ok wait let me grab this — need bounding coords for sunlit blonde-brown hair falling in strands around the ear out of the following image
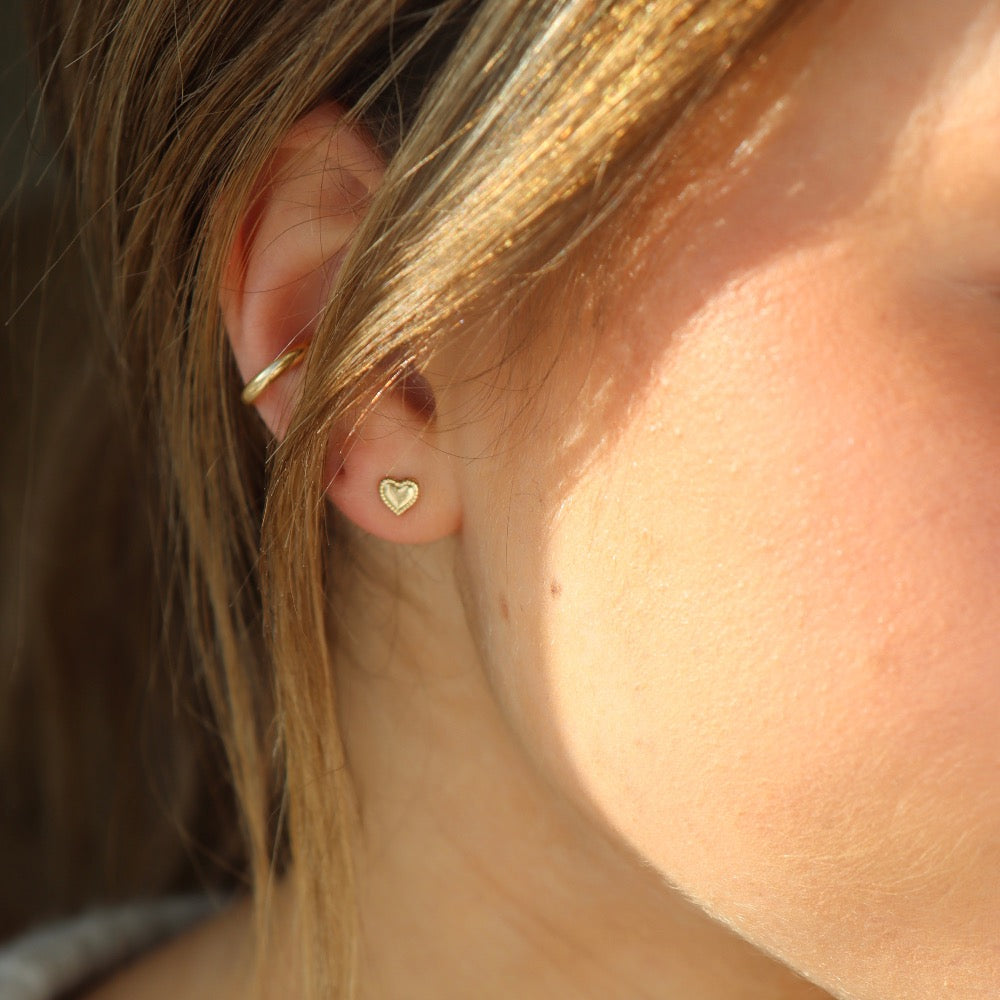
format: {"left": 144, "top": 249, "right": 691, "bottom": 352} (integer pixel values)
{"left": 25, "top": 0, "right": 804, "bottom": 996}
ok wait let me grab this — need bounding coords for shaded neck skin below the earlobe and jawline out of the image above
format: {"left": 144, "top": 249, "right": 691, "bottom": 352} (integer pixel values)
{"left": 324, "top": 547, "right": 827, "bottom": 1000}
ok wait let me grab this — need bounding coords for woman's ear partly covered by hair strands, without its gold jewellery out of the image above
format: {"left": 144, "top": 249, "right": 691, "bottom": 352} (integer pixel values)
{"left": 220, "top": 103, "right": 461, "bottom": 544}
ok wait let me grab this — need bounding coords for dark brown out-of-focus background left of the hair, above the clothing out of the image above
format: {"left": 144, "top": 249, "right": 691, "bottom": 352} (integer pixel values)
{"left": 0, "top": 0, "right": 242, "bottom": 942}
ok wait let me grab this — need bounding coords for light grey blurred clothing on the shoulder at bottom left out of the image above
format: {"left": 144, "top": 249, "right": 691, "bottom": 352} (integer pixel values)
{"left": 0, "top": 897, "right": 215, "bottom": 1000}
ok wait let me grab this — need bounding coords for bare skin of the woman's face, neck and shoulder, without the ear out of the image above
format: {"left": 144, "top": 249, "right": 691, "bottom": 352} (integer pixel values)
{"left": 90, "top": 0, "right": 1000, "bottom": 1000}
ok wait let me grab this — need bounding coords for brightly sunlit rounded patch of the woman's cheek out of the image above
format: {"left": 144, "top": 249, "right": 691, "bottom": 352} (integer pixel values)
{"left": 539, "top": 256, "right": 1000, "bottom": 984}
